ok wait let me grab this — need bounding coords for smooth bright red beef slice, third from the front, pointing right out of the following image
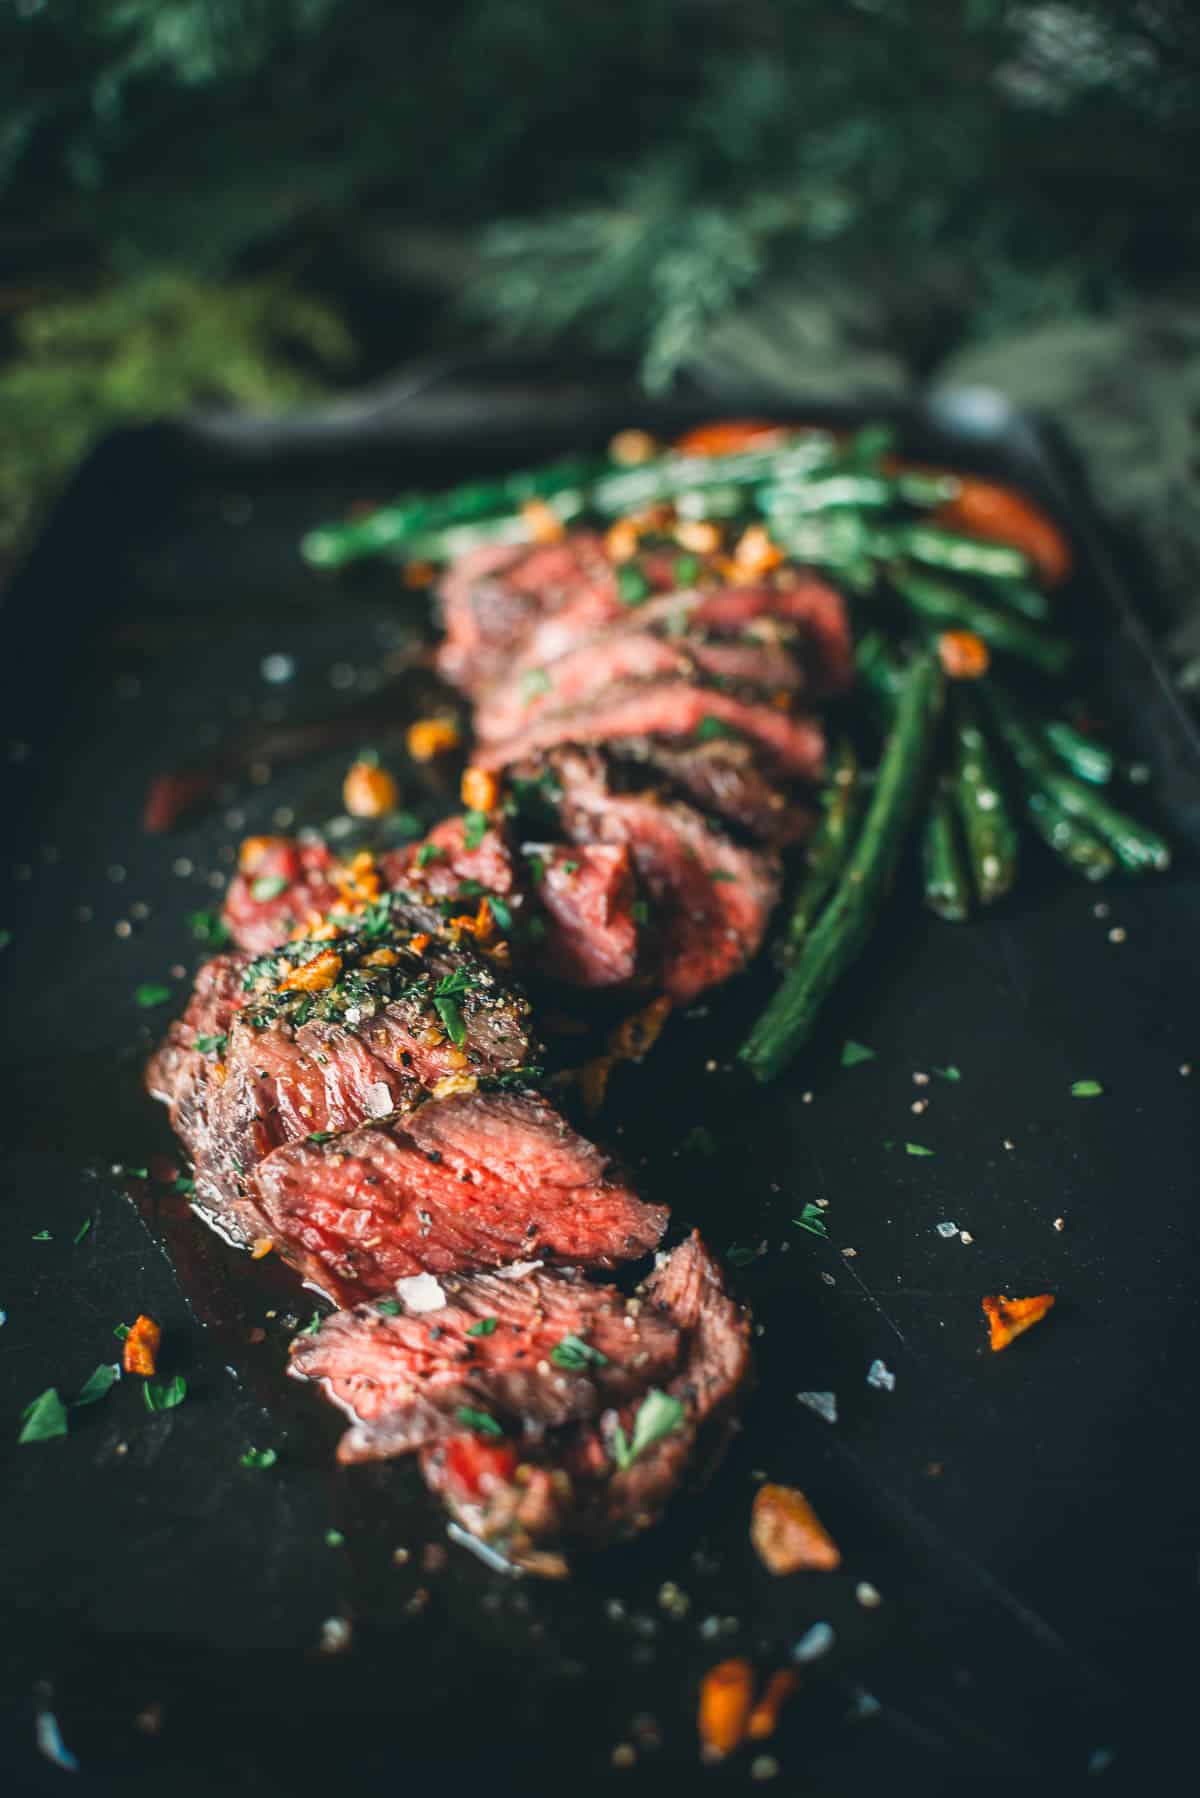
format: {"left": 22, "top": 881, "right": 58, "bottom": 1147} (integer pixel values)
{"left": 252, "top": 1091, "right": 666, "bottom": 1304}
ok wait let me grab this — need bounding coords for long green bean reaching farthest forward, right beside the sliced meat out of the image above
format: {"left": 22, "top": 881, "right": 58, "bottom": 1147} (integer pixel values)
{"left": 738, "top": 651, "right": 945, "bottom": 1081}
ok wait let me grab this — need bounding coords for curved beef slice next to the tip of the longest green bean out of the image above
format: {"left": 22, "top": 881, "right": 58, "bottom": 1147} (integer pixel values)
{"left": 547, "top": 750, "right": 781, "bottom": 1005}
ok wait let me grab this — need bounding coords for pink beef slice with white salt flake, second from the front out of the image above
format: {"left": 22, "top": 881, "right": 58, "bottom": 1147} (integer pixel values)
{"left": 290, "top": 1269, "right": 680, "bottom": 1462}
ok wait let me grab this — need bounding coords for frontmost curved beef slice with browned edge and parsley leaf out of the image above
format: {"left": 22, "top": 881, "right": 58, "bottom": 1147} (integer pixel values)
{"left": 421, "top": 1235, "right": 750, "bottom": 1562}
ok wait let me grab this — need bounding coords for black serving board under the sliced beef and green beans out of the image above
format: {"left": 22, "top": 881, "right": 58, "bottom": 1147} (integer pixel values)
{"left": 0, "top": 367, "right": 1200, "bottom": 1798}
